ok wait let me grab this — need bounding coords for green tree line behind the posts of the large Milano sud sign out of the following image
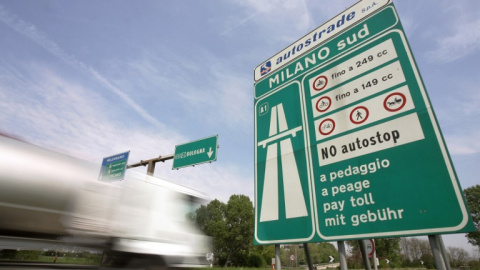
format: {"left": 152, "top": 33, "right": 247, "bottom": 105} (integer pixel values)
{"left": 187, "top": 185, "right": 480, "bottom": 269}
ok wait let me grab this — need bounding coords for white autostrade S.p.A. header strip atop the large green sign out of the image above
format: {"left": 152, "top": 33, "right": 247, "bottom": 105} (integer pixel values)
{"left": 254, "top": 0, "right": 391, "bottom": 82}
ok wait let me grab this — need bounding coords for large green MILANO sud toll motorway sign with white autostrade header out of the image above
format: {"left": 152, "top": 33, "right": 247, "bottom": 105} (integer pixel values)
{"left": 255, "top": 0, "right": 473, "bottom": 244}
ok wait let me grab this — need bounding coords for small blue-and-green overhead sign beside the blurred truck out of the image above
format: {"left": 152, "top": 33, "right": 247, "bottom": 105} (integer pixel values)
{"left": 99, "top": 151, "right": 130, "bottom": 181}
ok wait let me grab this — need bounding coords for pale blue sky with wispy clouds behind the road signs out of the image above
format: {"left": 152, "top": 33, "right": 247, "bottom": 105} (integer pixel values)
{"left": 0, "top": 0, "right": 480, "bottom": 254}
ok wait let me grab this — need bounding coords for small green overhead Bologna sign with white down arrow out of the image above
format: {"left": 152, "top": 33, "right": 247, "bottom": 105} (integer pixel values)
{"left": 172, "top": 135, "right": 218, "bottom": 169}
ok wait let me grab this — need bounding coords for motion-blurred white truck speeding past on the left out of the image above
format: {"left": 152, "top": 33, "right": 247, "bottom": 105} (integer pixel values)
{"left": 0, "top": 136, "right": 210, "bottom": 269}
